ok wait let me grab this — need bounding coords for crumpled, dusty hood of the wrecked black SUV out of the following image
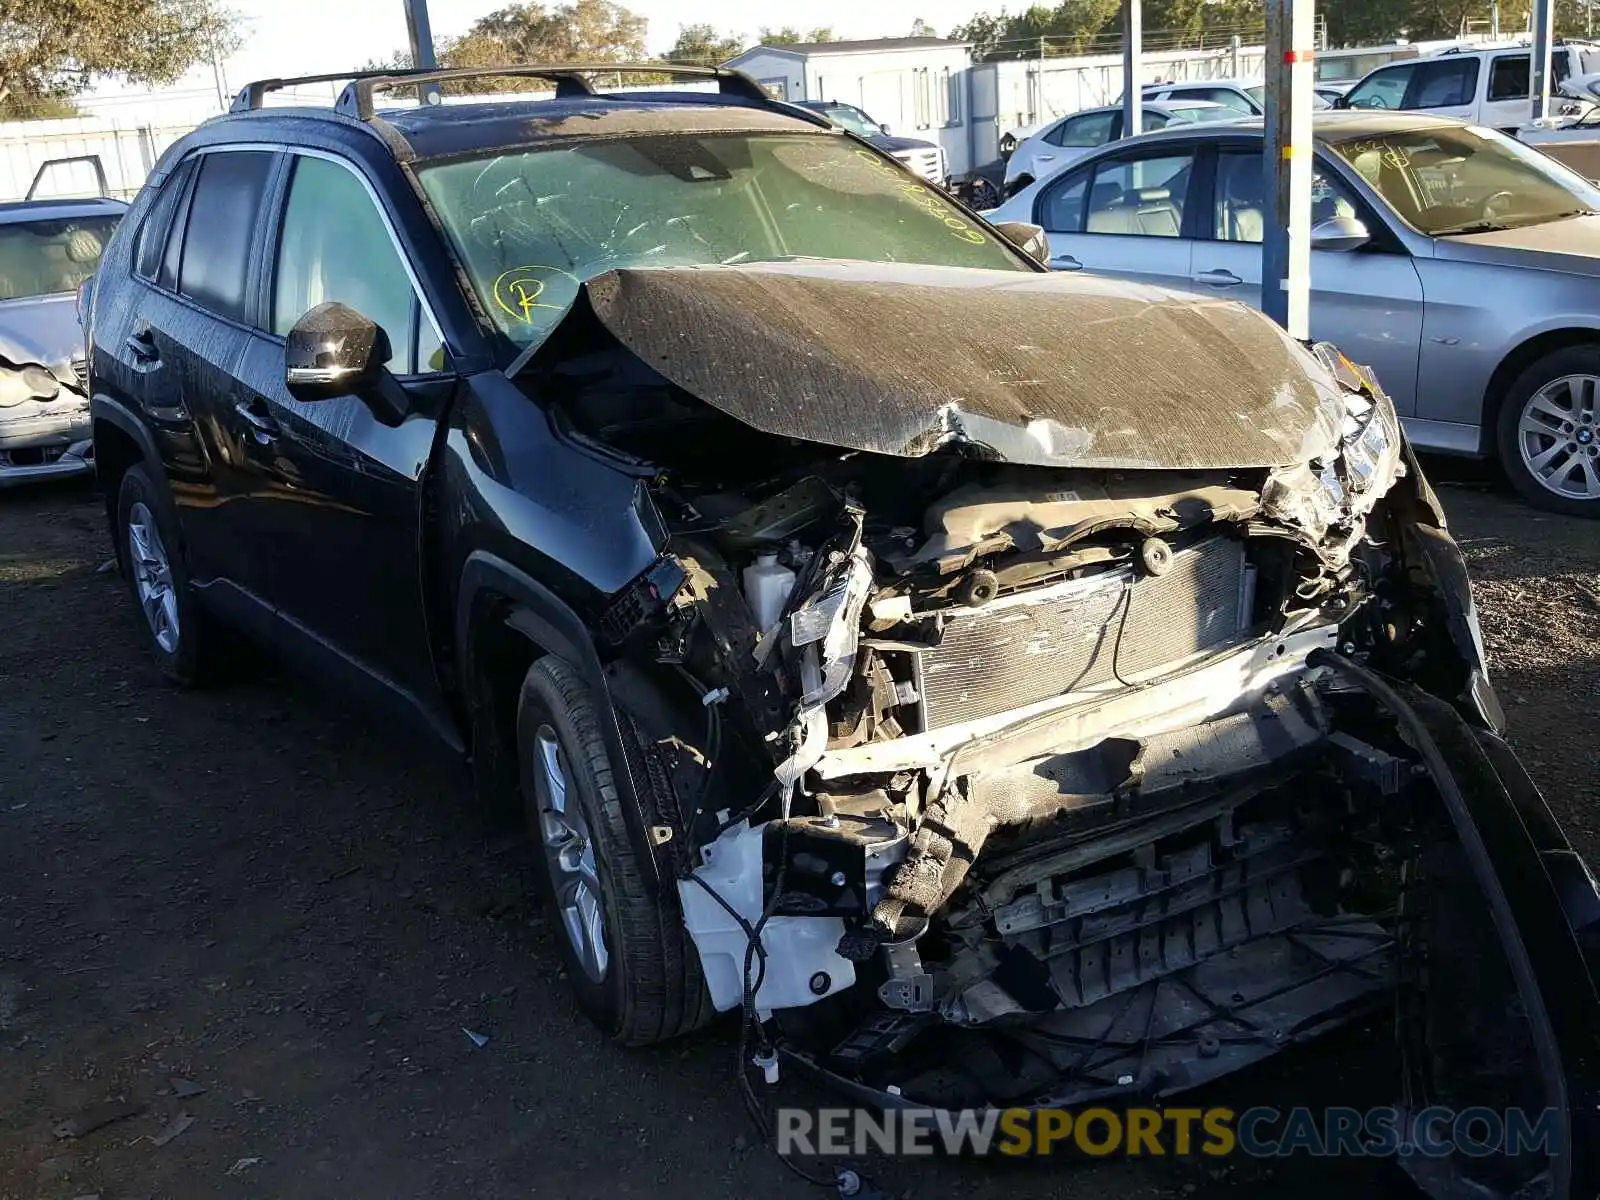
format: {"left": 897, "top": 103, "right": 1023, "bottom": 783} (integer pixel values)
{"left": 586, "top": 261, "right": 1342, "bottom": 470}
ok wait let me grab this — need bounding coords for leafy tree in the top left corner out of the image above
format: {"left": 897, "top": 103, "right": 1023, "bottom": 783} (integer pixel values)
{"left": 0, "top": 0, "right": 238, "bottom": 117}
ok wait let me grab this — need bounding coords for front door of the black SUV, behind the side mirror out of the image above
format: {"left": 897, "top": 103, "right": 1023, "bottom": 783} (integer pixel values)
{"left": 225, "top": 155, "right": 451, "bottom": 732}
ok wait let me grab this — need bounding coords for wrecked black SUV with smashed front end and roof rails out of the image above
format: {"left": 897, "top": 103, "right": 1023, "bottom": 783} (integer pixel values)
{"left": 90, "top": 62, "right": 1600, "bottom": 1200}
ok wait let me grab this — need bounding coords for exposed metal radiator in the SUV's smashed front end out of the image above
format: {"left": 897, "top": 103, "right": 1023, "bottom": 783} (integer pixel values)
{"left": 917, "top": 536, "right": 1248, "bottom": 730}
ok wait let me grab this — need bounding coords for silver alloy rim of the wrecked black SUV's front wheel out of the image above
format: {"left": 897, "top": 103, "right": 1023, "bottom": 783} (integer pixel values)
{"left": 534, "top": 725, "right": 611, "bottom": 984}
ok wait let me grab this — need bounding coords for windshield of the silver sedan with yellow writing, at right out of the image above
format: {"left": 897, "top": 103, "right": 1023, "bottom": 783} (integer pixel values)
{"left": 1330, "top": 125, "right": 1600, "bottom": 237}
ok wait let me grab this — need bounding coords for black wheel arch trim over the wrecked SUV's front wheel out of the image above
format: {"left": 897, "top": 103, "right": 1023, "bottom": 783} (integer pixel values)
{"left": 456, "top": 549, "right": 672, "bottom": 893}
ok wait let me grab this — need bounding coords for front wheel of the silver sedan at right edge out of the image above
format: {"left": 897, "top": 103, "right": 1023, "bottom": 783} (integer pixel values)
{"left": 1498, "top": 346, "right": 1600, "bottom": 517}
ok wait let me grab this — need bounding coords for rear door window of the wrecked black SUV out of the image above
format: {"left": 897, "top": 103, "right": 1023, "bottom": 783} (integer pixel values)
{"left": 178, "top": 150, "right": 272, "bottom": 320}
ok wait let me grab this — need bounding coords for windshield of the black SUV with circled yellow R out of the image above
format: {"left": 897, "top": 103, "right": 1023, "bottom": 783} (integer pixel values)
{"left": 418, "top": 134, "right": 1027, "bottom": 346}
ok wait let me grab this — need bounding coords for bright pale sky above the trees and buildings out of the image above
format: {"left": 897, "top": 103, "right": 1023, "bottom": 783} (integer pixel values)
{"left": 216, "top": 0, "right": 985, "bottom": 88}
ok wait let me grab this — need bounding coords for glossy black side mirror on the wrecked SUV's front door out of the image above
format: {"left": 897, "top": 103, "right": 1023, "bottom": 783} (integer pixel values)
{"left": 283, "top": 301, "right": 406, "bottom": 424}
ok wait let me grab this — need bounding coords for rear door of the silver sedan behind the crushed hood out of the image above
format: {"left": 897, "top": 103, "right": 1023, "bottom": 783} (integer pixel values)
{"left": 1034, "top": 141, "right": 1195, "bottom": 288}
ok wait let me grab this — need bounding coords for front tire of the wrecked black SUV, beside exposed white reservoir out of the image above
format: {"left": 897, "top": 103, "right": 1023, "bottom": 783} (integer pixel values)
{"left": 517, "top": 658, "right": 715, "bottom": 1046}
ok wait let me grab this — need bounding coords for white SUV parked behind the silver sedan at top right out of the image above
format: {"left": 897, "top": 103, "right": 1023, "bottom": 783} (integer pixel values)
{"left": 1334, "top": 42, "right": 1600, "bottom": 133}
